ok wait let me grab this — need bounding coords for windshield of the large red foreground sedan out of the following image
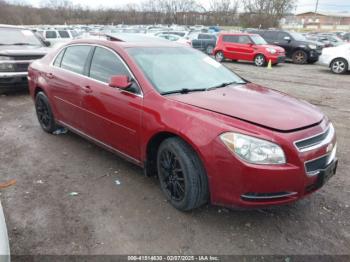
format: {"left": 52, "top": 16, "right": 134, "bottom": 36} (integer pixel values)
{"left": 128, "top": 47, "right": 245, "bottom": 93}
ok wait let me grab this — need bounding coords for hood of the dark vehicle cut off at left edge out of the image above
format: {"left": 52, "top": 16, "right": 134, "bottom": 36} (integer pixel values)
{"left": 0, "top": 45, "right": 50, "bottom": 56}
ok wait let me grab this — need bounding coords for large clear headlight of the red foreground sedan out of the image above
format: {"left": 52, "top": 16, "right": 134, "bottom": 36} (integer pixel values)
{"left": 220, "top": 132, "right": 286, "bottom": 165}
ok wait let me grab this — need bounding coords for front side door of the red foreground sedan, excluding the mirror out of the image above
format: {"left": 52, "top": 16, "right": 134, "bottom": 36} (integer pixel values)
{"left": 83, "top": 46, "right": 143, "bottom": 159}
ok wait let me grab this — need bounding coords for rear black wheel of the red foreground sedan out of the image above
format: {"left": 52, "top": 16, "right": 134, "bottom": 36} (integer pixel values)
{"left": 35, "top": 92, "right": 57, "bottom": 133}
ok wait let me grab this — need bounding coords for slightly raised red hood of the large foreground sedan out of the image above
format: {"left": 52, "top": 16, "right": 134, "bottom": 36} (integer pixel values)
{"left": 168, "top": 83, "right": 324, "bottom": 132}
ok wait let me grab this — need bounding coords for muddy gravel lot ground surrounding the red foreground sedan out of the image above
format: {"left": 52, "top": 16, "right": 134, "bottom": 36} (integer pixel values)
{"left": 0, "top": 63, "right": 350, "bottom": 255}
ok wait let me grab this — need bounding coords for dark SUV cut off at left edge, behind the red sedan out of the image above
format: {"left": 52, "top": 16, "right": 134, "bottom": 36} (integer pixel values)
{"left": 0, "top": 25, "right": 48, "bottom": 94}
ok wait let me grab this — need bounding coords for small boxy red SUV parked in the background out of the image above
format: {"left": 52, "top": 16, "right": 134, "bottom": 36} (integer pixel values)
{"left": 214, "top": 33, "right": 286, "bottom": 66}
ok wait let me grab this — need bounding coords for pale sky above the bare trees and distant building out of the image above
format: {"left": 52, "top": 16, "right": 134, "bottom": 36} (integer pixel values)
{"left": 14, "top": 0, "right": 350, "bottom": 13}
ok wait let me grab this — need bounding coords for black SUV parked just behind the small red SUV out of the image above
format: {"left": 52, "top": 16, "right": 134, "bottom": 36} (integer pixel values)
{"left": 249, "top": 30, "right": 324, "bottom": 64}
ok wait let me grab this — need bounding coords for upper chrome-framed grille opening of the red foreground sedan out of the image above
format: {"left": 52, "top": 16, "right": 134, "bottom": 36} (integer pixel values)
{"left": 294, "top": 124, "right": 335, "bottom": 152}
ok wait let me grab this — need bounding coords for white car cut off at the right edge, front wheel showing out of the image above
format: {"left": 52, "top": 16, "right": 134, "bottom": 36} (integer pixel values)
{"left": 319, "top": 43, "right": 350, "bottom": 74}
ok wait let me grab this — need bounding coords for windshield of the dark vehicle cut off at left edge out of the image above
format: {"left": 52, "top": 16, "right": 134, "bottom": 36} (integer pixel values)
{"left": 0, "top": 28, "right": 42, "bottom": 46}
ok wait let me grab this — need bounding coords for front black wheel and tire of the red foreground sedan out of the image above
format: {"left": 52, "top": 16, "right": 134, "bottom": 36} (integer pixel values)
{"left": 157, "top": 138, "right": 209, "bottom": 211}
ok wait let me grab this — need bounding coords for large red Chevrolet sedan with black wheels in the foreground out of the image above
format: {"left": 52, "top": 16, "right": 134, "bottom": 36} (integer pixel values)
{"left": 28, "top": 40, "right": 337, "bottom": 211}
